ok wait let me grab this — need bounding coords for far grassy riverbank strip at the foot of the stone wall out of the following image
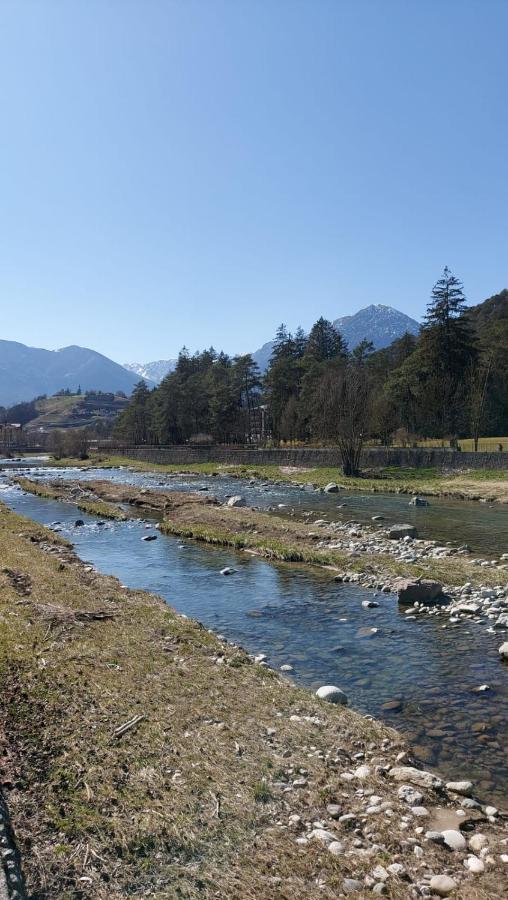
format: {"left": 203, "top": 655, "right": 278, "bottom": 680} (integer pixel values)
{"left": 49, "top": 454, "right": 508, "bottom": 503}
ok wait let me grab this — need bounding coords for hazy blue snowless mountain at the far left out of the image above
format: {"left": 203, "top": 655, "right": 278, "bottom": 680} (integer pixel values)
{"left": 0, "top": 340, "right": 143, "bottom": 406}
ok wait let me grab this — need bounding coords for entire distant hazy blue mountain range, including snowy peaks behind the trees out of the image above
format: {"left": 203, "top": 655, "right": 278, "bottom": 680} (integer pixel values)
{"left": 0, "top": 304, "right": 420, "bottom": 406}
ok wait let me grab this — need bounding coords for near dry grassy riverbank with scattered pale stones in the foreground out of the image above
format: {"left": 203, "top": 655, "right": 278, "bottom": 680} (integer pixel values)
{"left": 0, "top": 505, "right": 506, "bottom": 900}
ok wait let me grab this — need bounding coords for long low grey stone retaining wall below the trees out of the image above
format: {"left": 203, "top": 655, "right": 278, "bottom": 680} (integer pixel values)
{"left": 104, "top": 446, "right": 508, "bottom": 470}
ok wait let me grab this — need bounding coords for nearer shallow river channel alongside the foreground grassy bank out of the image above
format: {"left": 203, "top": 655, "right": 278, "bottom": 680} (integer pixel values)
{"left": 0, "top": 470, "right": 508, "bottom": 804}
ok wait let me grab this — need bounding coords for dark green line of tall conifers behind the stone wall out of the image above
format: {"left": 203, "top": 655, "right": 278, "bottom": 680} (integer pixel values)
{"left": 115, "top": 268, "right": 508, "bottom": 472}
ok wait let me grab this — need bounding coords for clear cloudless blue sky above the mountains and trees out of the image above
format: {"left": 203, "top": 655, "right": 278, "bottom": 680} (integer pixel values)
{"left": 0, "top": 0, "right": 508, "bottom": 362}
